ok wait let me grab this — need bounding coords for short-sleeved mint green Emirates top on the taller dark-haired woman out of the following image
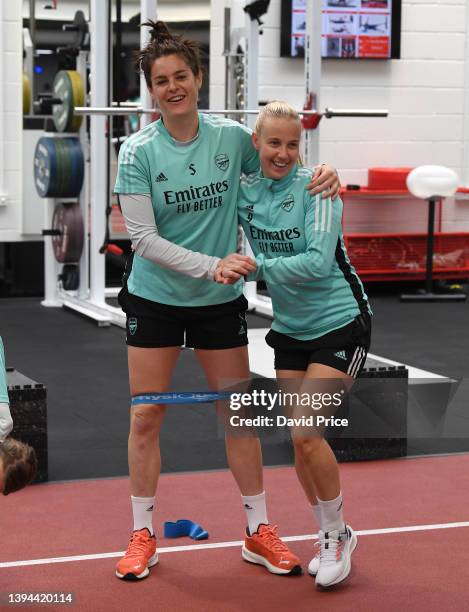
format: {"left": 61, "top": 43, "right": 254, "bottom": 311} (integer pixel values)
{"left": 115, "top": 113, "right": 259, "bottom": 306}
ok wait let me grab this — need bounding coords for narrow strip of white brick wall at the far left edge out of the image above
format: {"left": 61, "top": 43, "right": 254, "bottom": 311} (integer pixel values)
{"left": 0, "top": 2, "right": 23, "bottom": 240}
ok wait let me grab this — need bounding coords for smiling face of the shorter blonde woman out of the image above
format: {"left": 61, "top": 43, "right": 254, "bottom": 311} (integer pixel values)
{"left": 252, "top": 117, "right": 301, "bottom": 180}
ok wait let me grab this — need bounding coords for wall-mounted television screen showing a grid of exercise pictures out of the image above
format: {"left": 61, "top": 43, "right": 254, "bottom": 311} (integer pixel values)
{"left": 280, "top": 0, "right": 401, "bottom": 59}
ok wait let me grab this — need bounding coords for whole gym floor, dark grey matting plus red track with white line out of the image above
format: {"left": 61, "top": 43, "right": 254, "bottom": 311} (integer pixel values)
{"left": 0, "top": 285, "right": 469, "bottom": 611}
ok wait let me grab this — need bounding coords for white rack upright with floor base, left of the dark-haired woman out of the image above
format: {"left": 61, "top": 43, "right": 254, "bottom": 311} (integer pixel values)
{"left": 42, "top": 0, "right": 158, "bottom": 327}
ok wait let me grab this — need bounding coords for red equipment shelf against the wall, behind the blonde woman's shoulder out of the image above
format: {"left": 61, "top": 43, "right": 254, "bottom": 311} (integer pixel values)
{"left": 341, "top": 187, "right": 469, "bottom": 281}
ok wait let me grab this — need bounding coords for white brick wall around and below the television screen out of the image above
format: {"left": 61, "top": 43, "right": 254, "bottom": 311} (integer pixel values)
{"left": 210, "top": 0, "right": 469, "bottom": 186}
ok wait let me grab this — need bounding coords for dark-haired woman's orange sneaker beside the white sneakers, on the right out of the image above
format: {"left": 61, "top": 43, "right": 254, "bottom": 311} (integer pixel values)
{"left": 242, "top": 524, "right": 301, "bottom": 575}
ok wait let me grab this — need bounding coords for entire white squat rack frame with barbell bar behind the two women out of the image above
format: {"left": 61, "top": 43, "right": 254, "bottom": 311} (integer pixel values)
{"left": 42, "top": 0, "right": 388, "bottom": 327}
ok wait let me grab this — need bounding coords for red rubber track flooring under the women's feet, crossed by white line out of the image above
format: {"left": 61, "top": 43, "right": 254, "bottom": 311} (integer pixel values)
{"left": 0, "top": 455, "right": 469, "bottom": 612}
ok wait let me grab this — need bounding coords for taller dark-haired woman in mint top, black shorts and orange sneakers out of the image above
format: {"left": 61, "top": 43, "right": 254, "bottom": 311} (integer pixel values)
{"left": 115, "top": 21, "right": 339, "bottom": 580}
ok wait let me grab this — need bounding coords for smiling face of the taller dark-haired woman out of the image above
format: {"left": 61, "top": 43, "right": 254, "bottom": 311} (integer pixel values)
{"left": 149, "top": 54, "right": 202, "bottom": 121}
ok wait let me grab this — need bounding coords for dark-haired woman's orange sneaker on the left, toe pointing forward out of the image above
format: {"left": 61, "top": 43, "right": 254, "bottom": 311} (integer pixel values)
{"left": 116, "top": 527, "right": 158, "bottom": 580}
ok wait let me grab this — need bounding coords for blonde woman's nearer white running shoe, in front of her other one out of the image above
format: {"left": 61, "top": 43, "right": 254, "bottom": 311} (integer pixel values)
{"left": 316, "top": 525, "right": 357, "bottom": 587}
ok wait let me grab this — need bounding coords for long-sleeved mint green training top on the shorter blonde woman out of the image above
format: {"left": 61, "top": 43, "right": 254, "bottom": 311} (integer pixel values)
{"left": 238, "top": 166, "right": 371, "bottom": 340}
